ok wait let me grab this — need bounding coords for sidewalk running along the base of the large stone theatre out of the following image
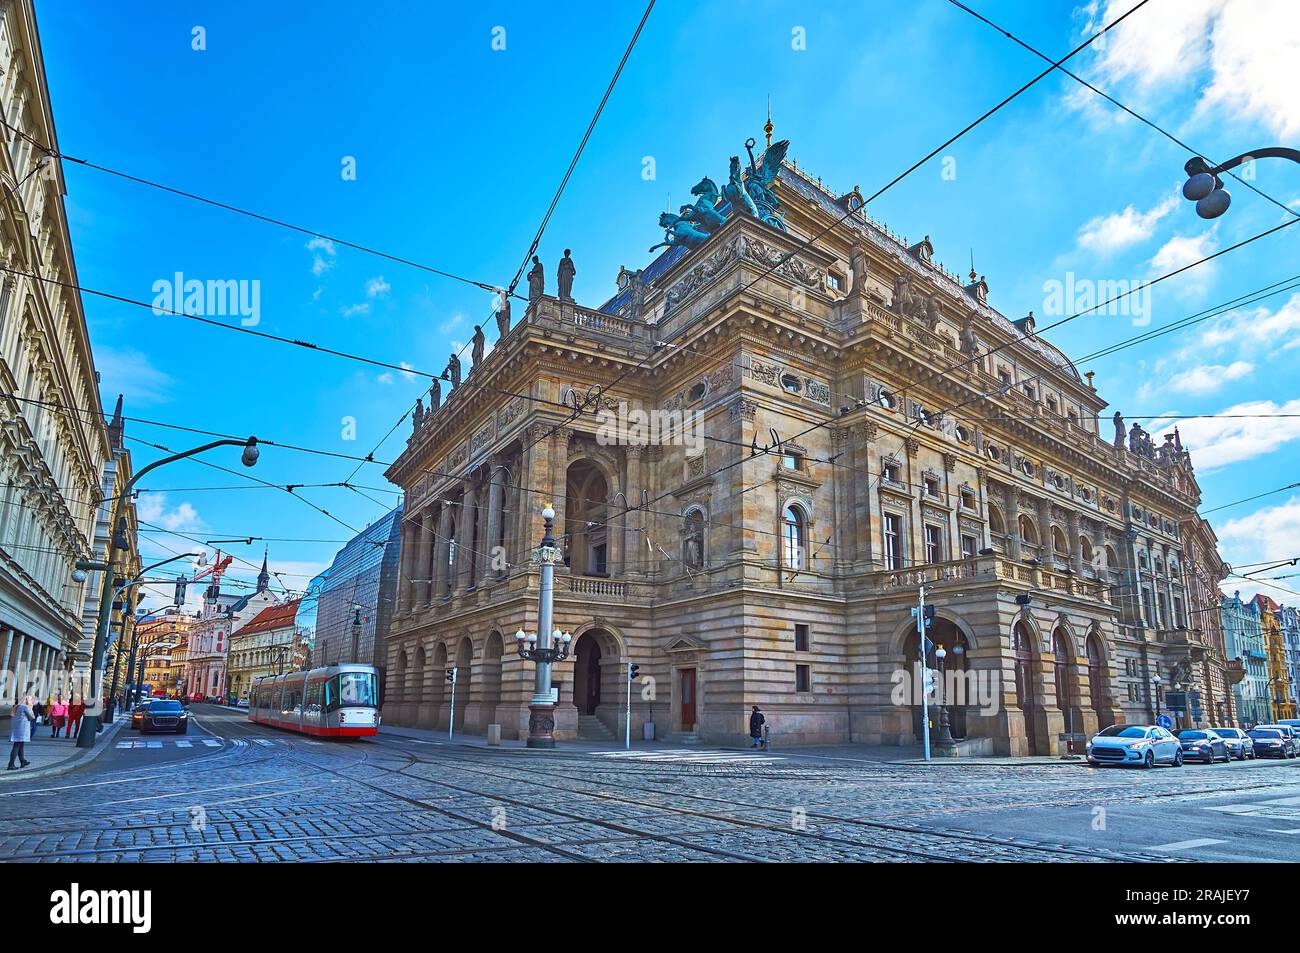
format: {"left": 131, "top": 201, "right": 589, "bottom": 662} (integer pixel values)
{"left": 380, "top": 725, "right": 1088, "bottom": 767}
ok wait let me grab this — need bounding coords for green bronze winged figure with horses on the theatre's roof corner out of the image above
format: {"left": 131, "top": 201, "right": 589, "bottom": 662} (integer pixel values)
{"left": 650, "top": 139, "right": 790, "bottom": 251}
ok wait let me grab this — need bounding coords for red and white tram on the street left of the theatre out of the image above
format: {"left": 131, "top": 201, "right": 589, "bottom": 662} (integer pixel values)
{"left": 248, "top": 663, "right": 380, "bottom": 738}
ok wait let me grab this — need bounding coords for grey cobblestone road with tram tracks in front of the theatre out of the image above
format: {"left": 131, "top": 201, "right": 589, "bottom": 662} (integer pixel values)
{"left": 0, "top": 706, "right": 1300, "bottom": 863}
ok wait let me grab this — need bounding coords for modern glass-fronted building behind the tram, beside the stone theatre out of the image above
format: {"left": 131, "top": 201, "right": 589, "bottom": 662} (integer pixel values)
{"left": 308, "top": 506, "right": 402, "bottom": 685}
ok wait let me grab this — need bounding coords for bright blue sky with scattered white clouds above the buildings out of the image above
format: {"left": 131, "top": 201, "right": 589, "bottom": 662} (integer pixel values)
{"left": 30, "top": 0, "right": 1300, "bottom": 601}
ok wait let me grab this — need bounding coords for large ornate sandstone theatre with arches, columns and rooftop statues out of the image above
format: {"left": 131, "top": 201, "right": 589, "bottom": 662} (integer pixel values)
{"left": 384, "top": 140, "right": 1232, "bottom": 755}
